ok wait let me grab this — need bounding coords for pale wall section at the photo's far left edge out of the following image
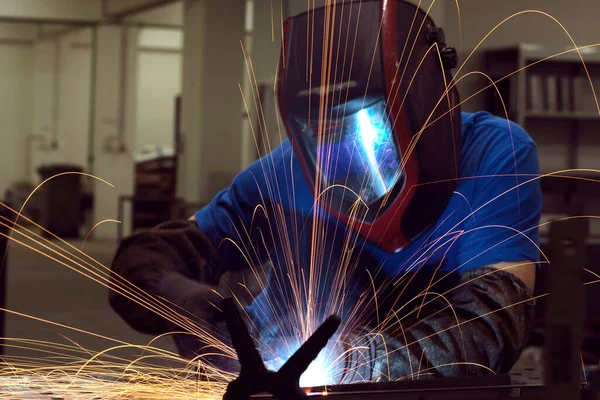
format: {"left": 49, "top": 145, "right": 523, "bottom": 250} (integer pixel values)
{"left": 0, "top": 43, "right": 33, "bottom": 196}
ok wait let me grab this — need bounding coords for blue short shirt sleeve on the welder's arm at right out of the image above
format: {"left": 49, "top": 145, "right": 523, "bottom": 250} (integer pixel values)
{"left": 457, "top": 123, "right": 542, "bottom": 271}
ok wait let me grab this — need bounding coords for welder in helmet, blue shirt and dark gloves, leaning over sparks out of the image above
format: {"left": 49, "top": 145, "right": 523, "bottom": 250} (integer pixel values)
{"left": 110, "top": 0, "right": 541, "bottom": 383}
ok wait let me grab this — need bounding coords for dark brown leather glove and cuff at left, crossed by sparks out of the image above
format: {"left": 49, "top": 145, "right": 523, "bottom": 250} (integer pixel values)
{"left": 109, "top": 221, "right": 226, "bottom": 356}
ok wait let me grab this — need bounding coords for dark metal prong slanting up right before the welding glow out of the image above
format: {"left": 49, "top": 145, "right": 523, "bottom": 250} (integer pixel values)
{"left": 279, "top": 315, "right": 342, "bottom": 380}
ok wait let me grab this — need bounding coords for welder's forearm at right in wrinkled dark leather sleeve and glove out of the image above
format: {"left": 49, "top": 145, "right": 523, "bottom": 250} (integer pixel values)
{"left": 344, "top": 262, "right": 535, "bottom": 383}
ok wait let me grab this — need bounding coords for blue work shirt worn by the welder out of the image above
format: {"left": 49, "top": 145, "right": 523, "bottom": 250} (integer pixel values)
{"left": 196, "top": 112, "right": 542, "bottom": 348}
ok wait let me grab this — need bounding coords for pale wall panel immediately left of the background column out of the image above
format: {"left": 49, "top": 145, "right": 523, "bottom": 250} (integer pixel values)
{"left": 30, "top": 29, "right": 92, "bottom": 183}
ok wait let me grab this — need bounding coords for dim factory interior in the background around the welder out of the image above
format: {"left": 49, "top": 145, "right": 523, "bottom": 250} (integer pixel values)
{"left": 0, "top": 0, "right": 600, "bottom": 399}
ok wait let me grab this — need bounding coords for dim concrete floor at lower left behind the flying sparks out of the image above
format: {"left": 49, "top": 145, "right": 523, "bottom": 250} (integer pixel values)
{"left": 5, "top": 241, "right": 175, "bottom": 366}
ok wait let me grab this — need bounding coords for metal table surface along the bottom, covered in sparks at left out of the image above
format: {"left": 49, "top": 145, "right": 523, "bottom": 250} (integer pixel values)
{"left": 0, "top": 370, "right": 543, "bottom": 400}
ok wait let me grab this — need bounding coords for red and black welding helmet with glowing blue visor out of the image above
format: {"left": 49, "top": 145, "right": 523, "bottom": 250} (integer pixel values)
{"left": 278, "top": 0, "right": 461, "bottom": 252}
